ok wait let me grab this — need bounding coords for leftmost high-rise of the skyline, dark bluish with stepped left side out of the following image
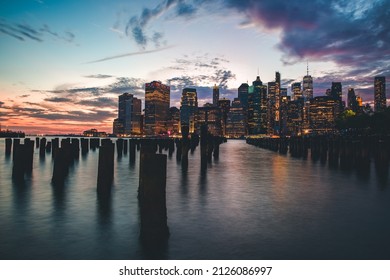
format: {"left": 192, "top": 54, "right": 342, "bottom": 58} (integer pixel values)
{"left": 113, "top": 92, "right": 141, "bottom": 135}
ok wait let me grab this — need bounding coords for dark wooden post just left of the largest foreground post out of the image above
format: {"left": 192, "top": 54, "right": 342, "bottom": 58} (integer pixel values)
{"left": 97, "top": 139, "right": 115, "bottom": 194}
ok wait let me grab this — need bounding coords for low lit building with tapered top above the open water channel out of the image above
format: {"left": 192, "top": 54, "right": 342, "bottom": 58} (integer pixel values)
{"left": 225, "top": 98, "right": 246, "bottom": 138}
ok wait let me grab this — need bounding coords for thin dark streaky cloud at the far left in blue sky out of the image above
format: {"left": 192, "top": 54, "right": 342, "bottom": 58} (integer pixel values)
{"left": 0, "top": 19, "right": 75, "bottom": 43}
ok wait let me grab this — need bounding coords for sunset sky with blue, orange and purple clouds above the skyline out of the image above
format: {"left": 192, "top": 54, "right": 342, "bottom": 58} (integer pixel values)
{"left": 0, "top": 0, "right": 390, "bottom": 134}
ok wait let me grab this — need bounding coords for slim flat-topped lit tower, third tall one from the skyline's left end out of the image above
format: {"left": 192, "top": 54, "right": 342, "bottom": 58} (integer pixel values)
{"left": 180, "top": 88, "right": 198, "bottom": 133}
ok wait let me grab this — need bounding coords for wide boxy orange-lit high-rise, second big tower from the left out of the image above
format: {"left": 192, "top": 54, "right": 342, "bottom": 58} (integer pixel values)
{"left": 144, "top": 81, "right": 170, "bottom": 135}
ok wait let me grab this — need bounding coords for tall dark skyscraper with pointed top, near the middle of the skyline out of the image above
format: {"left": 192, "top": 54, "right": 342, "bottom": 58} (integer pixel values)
{"left": 248, "top": 76, "right": 267, "bottom": 135}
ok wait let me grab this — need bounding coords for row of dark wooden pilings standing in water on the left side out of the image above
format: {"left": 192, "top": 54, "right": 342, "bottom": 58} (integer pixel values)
{"left": 5, "top": 130, "right": 224, "bottom": 244}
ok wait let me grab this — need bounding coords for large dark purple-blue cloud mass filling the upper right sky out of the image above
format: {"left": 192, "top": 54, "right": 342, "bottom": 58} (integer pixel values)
{"left": 224, "top": 0, "right": 390, "bottom": 72}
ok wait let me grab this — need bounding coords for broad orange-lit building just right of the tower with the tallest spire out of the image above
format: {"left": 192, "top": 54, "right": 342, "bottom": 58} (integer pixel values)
{"left": 309, "top": 96, "right": 339, "bottom": 134}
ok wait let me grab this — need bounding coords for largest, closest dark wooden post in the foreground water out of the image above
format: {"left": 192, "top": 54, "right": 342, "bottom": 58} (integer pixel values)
{"left": 138, "top": 143, "right": 169, "bottom": 244}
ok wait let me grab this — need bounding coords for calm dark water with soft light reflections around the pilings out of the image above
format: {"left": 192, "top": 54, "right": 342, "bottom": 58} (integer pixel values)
{"left": 0, "top": 139, "right": 390, "bottom": 259}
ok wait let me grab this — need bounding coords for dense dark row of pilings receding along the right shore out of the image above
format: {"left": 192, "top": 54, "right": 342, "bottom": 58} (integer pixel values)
{"left": 247, "top": 135, "right": 390, "bottom": 166}
